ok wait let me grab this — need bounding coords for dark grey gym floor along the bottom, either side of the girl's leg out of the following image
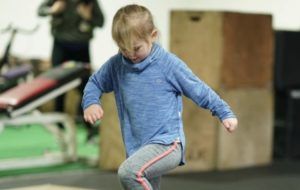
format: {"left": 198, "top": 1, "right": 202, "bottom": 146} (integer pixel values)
{"left": 0, "top": 161, "right": 300, "bottom": 190}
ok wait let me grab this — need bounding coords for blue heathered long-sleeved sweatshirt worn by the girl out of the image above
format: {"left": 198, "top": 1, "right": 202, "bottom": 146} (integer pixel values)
{"left": 82, "top": 43, "right": 235, "bottom": 163}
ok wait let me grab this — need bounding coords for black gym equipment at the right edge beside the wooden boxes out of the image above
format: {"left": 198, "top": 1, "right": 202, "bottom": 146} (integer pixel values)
{"left": 273, "top": 30, "right": 300, "bottom": 160}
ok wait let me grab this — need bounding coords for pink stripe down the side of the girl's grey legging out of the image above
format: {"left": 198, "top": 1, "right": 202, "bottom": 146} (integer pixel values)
{"left": 137, "top": 142, "right": 178, "bottom": 190}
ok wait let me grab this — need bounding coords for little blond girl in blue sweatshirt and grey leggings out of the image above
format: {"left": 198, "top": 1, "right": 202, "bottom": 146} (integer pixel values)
{"left": 82, "top": 5, "right": 237, "bottom": 190}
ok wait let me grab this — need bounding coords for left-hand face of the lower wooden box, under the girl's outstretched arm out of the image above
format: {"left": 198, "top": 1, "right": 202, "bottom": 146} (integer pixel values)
{"left": 176, "top": 98, "right": 218, "bottom": 172}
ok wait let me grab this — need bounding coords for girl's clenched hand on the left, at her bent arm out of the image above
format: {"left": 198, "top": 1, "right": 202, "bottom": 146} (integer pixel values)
{"left": 83, "top": 104, "right": 103, "bottom": 124}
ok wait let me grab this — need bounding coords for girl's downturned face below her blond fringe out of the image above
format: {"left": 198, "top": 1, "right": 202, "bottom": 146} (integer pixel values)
{"left": 120, "top": 39, "right": 152, "bottom": 63}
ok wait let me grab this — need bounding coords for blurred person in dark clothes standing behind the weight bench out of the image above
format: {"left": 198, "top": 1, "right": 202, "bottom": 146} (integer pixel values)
{"left": 38, "top": 0, "right": 104, "bottom": 141}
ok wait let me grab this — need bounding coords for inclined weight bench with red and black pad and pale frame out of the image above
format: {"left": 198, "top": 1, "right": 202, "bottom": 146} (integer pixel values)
{"left": 0, "top": 62, "right": 90, "bottom": 170}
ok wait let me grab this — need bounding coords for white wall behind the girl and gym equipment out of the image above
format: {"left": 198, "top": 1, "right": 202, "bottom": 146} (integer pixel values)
{"left": 0, "top": 0, "right": 300, "bottom": 69}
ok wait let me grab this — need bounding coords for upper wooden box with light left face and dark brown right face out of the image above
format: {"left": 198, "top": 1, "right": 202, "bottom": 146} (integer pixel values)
{"left": 170, "top": 11, "right": 274, "bottom": 89}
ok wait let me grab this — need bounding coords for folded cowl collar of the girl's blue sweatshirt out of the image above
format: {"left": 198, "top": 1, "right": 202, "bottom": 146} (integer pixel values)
{"left": 122, "top": 43, "right": 163, "bottom": 72}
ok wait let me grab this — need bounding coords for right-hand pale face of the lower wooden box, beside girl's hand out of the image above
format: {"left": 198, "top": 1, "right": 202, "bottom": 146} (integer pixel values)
{"left": 216, "top": 89, "right": 274, "bottom": 169}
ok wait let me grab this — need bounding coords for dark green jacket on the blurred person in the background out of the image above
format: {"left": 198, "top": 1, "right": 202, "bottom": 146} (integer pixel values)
{"left": 38, "top": 0, "right": 104, "bottom": 42}
